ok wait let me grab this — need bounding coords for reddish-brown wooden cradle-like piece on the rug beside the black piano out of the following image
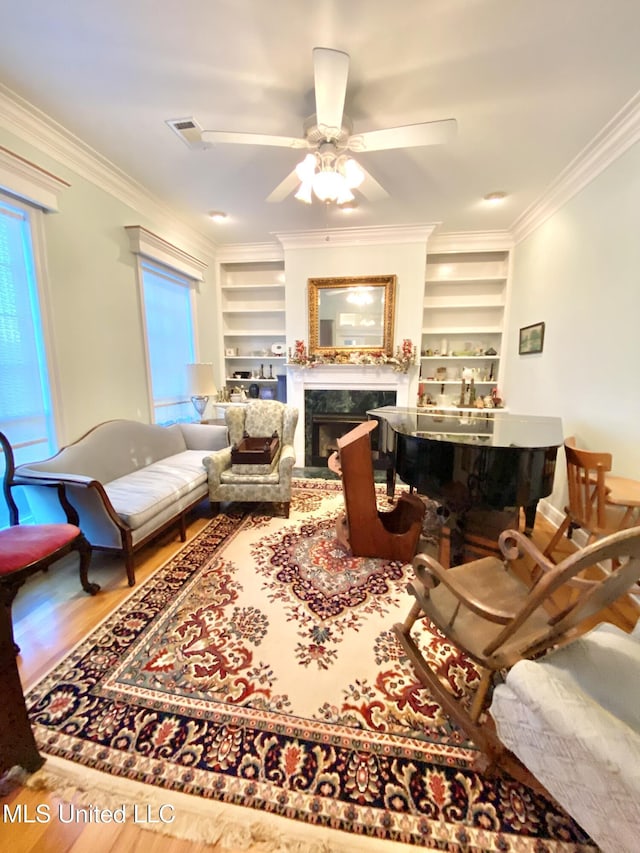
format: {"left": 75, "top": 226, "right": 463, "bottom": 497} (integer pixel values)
{"left": 329, "top": 421, "right": 426, "bottom": 563}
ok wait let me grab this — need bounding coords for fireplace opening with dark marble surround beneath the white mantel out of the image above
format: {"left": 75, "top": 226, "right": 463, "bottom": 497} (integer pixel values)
{"left": 304, "top": 389, "right": 396, "bottom": 467}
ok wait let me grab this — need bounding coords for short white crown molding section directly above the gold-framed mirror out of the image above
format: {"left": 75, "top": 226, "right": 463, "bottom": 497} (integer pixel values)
{"left": 274, "top": 223, "right": 438, "bottom": 250}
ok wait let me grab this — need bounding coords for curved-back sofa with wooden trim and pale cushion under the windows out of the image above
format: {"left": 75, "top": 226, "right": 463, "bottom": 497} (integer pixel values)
{"left": 16, "top": 420, "right": 228, "bottom": 586}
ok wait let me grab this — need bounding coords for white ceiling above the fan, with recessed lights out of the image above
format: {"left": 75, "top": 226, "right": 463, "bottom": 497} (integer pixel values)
{"left": 0, "top": 0, "right": 640, "bottom": 243}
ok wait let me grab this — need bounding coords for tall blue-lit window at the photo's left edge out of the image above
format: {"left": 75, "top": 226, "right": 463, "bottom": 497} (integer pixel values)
{"left": 0, "top": 196, "right": 56, "bottom": 527}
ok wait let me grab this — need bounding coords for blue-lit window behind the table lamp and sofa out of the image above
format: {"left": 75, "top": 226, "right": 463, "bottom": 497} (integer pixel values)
{"left": 140, "top": 260, "right": 195, "bottom": 425}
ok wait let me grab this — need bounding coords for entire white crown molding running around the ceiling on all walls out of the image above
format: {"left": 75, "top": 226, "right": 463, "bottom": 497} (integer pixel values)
{"left": 0, "top": 83, "right": 640, "bottom": 261}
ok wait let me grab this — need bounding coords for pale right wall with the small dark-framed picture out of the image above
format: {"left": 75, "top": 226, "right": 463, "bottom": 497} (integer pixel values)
{"left": 504, "top": 143, "right": 640, "bottom": 508}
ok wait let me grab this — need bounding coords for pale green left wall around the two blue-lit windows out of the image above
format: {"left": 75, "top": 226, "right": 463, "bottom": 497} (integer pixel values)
{"left": 0, "top": 128, "right": 219, "bottom": 444}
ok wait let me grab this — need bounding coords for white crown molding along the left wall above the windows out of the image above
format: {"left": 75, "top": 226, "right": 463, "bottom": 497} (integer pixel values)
{"left": 0, "top": 83, "right": 217, "bottom": 262}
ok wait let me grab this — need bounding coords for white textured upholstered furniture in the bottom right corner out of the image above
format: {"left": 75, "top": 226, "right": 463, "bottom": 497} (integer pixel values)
{"left": 491, "top": 623, "right": 640, "bottom": 853}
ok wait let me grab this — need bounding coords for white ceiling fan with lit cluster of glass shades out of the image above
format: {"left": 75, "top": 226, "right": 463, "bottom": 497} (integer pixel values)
{"left": 169, "top": 47, "right": 457, "bottom": 204}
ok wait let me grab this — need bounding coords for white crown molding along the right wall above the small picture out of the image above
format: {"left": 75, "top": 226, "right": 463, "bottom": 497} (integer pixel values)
{"left": 510, "top": 92, "right": 640, "bottom": 243}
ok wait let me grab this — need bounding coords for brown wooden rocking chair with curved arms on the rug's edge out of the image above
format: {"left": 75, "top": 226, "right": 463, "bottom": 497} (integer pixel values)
{"left": 393, "top": 527, "right": 640, "bottom": 787}
